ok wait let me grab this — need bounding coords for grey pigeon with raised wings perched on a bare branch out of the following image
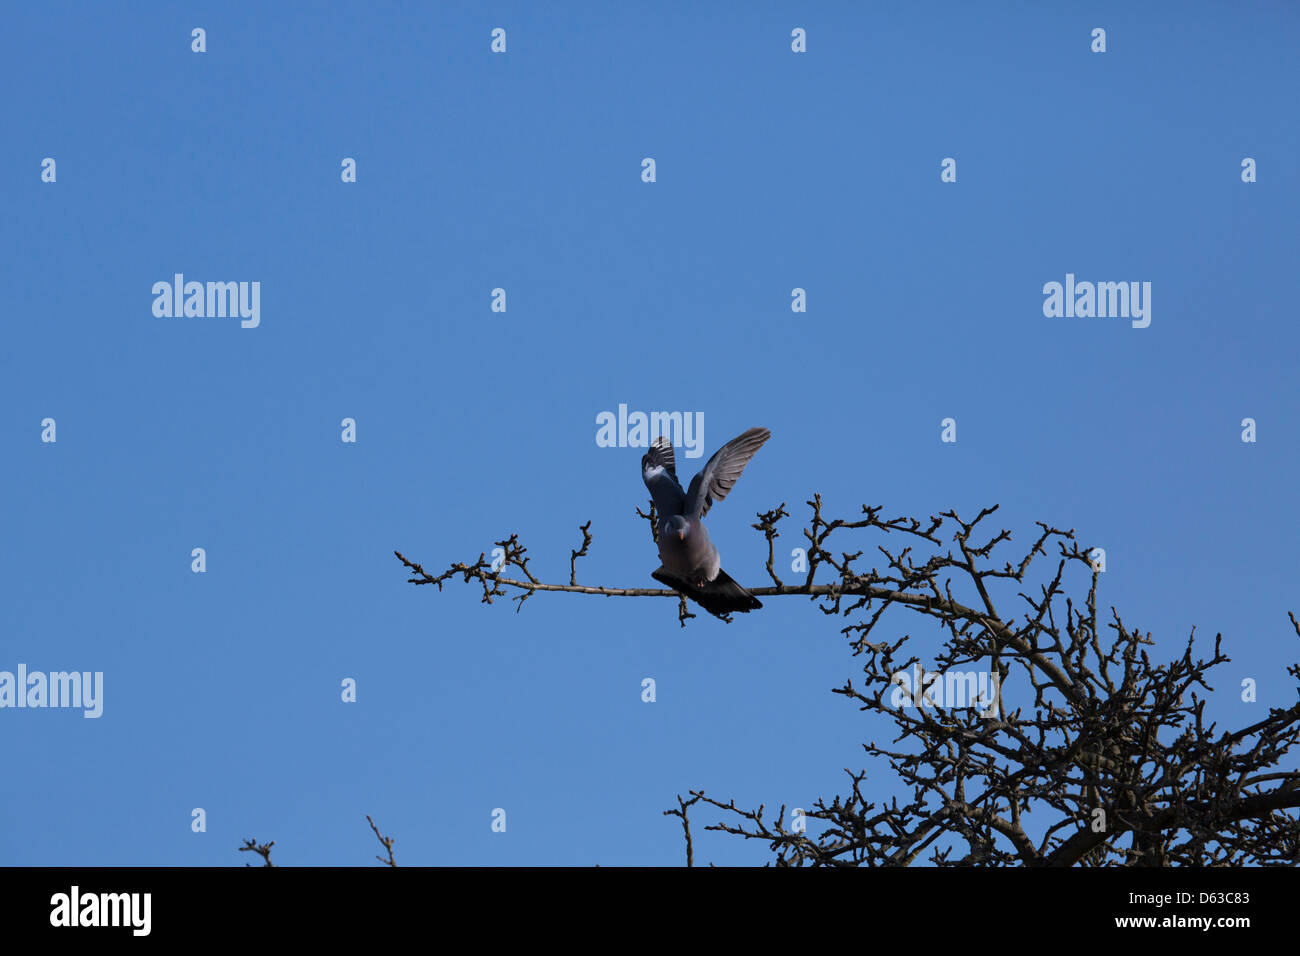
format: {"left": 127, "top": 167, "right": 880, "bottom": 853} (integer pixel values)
{"left": 641, "top": 428, "right": 772, "bottom": 618}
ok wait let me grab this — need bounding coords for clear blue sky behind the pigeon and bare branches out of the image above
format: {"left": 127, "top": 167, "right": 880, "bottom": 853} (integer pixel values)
{"left": 0, "top": 3, "right": 1300, "bottom": 865}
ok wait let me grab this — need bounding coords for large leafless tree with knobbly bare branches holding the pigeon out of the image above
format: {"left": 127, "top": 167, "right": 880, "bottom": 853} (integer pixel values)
{"left": 397, "top": 496, "right": 1300, "bottom": 866}
